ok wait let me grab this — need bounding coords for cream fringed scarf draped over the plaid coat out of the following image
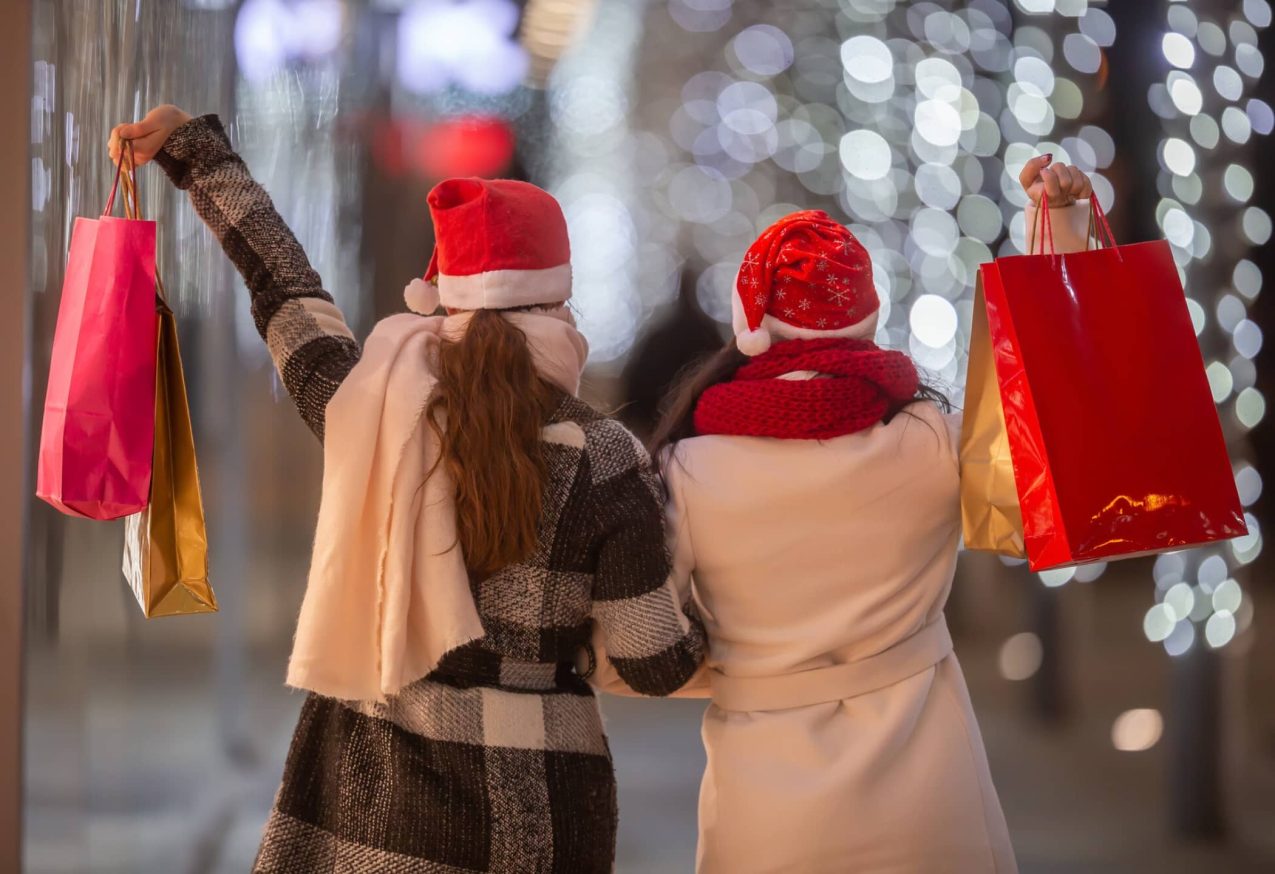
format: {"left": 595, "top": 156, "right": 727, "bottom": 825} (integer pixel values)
{"left": 287, "top": 307, "right": 588, "bottom": 700}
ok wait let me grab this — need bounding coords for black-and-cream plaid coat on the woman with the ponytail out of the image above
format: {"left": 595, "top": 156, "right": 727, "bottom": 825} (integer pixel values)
{"left": 158, "top": 116, "right": 704, "bottom": 874}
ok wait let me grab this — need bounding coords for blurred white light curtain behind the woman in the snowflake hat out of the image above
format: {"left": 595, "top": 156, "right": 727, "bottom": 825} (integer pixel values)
{"left": 642, "top": 0, "right": 1116, "bottom": 387}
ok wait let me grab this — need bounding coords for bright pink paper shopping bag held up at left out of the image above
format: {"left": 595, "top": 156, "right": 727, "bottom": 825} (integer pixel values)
{"left": 36, "top": 156, "right": 158, "bottom": 519}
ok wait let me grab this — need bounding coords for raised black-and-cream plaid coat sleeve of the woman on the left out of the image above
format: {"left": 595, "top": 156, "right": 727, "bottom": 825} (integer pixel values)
{"left": 156, "top": 115, "right": 360, "bottom": 439}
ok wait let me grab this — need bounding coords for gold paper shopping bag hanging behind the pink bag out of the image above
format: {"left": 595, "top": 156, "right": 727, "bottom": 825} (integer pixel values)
{"left": 124, "top": 294, "right": 217, "bottom": 618}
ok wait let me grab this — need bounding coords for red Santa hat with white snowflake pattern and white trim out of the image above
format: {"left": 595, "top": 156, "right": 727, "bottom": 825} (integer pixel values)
{"left": 731, "top": 209, "right": 881, "bottom": 355}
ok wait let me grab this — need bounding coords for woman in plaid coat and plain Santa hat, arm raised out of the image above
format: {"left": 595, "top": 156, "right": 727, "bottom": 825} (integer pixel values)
{"left": 112, "top": 106, "right": 704, "bottom": 874}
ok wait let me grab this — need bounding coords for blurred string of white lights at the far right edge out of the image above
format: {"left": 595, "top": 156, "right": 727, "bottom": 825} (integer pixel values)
{"left": 1142, "top": 0, "right": 1275, "bottom": 656}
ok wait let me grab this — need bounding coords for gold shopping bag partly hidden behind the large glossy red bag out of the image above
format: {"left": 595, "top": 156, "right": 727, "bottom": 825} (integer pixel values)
{"left": 960, "top": 270, "right": 1026, "bottom": 559}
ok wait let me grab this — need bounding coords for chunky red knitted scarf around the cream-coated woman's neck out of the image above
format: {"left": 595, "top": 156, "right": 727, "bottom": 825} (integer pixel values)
{"left": 695, "top": 338, "right": 921, "bottom": 440}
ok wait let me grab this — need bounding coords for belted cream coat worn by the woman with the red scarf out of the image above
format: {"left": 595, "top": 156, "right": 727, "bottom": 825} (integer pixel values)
{"left": 624, "top": 203, "right": 1088, "bottom": 874}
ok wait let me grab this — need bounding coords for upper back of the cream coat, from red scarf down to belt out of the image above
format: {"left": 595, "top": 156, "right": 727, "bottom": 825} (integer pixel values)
{"left": 666, "top": 402, "right": 960, "bottom": 678}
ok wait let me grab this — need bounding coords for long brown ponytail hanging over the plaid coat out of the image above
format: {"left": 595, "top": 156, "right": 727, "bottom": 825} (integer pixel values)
{"left": 425, "top": 310, "right": 558, "bottom": 575}
